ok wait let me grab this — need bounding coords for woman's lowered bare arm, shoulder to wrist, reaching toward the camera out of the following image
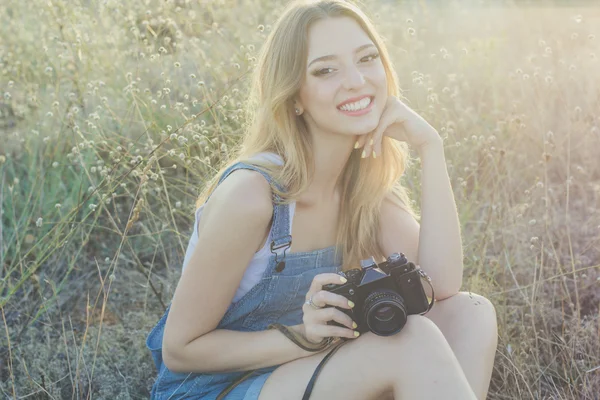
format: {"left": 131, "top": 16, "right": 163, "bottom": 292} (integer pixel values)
{"left": 163, "top": 170, "right": 310, "bottom": 373}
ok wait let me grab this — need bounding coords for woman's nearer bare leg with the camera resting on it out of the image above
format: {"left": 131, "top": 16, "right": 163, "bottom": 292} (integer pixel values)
{"left": 259, "top": 315, "right": 475, "bottom": 400}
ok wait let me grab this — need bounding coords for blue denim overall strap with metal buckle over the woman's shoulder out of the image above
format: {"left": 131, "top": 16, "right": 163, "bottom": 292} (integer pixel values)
{"left": 206, "top": 162, "right": 292, "bottom": 272}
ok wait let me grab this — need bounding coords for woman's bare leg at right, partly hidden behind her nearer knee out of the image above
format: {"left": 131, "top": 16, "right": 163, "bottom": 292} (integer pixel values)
{"left": 425, "top": 292, "right": 498, "bottom": 399}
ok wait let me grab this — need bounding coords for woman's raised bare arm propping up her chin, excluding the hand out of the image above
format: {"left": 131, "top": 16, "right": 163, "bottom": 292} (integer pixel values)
{"left": 380, "top": 140, "right": 463, "bottom": 300}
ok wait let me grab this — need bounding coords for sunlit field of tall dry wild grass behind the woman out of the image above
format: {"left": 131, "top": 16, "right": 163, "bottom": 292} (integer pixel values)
{"left": 0, "top": 0, "right": 600, "bottom": 400}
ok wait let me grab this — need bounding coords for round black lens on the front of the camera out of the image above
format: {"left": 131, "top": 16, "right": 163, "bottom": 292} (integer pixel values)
{"left": 363, "top": 290, "right": 407, "bottom": 336}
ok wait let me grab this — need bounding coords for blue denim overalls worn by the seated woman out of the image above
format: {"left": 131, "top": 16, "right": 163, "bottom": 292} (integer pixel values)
{"left": 146, "top": 162, "right": 342, "bottom": 400}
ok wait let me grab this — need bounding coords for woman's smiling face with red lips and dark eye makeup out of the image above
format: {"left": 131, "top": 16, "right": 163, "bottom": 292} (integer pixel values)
{"left": 297, "top": 17, "right": 387, "bottom": 139}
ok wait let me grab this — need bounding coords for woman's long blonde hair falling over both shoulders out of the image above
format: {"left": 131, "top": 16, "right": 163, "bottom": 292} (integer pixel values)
{"left": 196, "top": 0, "right": 415, "bottom": 270}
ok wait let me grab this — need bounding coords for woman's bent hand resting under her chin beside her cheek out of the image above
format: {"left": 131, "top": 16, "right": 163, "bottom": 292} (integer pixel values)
{"left": 357, "top": 95, "right": 442, "bottom": 158}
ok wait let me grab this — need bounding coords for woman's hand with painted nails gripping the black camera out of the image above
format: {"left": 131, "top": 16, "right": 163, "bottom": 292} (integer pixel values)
{"left": 302, "top": 273, "right": 358, "bottom": 343}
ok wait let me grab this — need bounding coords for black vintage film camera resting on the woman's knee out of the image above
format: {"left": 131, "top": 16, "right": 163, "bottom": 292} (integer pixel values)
{"left": 323, "top": 253, "right": 433, "bottom": 336}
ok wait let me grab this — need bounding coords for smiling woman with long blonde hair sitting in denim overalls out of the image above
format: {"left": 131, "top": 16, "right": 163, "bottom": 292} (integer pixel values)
{"left": 147, "top": 0, "right": 497, "bottom": 400}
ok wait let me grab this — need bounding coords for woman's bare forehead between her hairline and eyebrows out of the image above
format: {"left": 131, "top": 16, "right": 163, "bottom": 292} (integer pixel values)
{"left": 308, "top": 17, "right": 373, "bottom": 60}
